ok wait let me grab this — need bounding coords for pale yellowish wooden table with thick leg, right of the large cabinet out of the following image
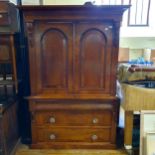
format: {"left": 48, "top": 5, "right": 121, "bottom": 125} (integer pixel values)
{"left": 121, "top": 84, "right": 155, "bottom": 149}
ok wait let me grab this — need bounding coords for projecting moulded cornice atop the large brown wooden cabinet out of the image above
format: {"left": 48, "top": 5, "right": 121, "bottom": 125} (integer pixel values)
{"left": 18, "top": 5, "right": 130, "bottom": 22}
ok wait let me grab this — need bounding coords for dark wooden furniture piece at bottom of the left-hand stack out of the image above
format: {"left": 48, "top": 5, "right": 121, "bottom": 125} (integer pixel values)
{"left": 0, "top": 99, "right": 19, "bottom": 155}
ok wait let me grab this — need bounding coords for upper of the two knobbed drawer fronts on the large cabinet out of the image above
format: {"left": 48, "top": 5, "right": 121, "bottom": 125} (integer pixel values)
{"left": 35, "top": 110, "right": 112, "bottom": 126}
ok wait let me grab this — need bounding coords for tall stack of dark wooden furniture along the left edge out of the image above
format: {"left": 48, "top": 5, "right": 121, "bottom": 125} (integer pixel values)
{"left": 0, "top": 1, "right": 19, "bottom": 155}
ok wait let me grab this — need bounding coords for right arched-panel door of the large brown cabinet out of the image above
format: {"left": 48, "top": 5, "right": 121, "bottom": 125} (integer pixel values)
{"left": 74, "top": 22, "right": 112, "bottom": 93}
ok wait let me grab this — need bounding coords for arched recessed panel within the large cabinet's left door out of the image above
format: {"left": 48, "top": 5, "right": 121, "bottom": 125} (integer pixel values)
{"left": 41, "top": 29, "right": 68, "bottom": 88}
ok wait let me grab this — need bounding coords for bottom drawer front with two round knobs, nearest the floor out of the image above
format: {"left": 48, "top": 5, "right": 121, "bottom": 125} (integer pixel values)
{"left": 36, "top": 127, "right": 110, "bottom": 142}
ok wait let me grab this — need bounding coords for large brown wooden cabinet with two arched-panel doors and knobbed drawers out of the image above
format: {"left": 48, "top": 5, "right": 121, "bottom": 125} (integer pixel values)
{"left": 20, "top": 5, "right": 128, "bottom": 148}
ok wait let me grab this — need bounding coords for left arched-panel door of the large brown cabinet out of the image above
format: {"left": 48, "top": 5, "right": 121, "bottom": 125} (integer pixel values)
{"left": 33, "top": 22, "right": 73, "bottom": 94}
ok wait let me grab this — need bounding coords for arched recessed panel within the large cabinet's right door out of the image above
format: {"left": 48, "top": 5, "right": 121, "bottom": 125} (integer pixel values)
{"left": 79, "top": 29, "right": 106, "bottom": 88}
